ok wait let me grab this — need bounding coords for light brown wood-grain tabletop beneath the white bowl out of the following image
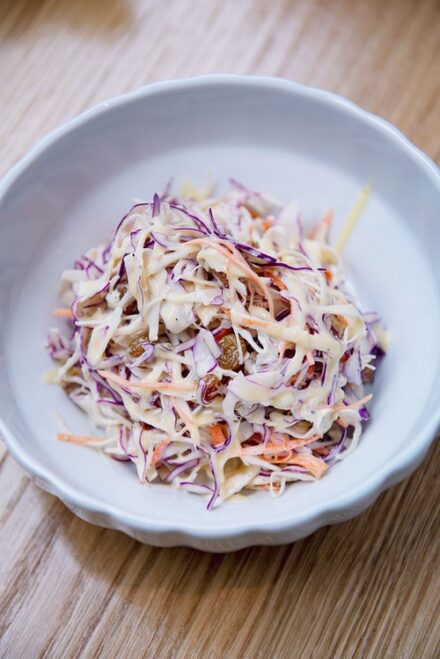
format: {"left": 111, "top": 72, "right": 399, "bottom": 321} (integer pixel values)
{"left": 0, "top": 0, "right": 440, "bottom": 659}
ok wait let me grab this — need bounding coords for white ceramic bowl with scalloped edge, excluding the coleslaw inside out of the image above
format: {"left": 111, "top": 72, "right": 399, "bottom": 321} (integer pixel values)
{"left": 0, "top": 75, "right": 440, "bottom": 551}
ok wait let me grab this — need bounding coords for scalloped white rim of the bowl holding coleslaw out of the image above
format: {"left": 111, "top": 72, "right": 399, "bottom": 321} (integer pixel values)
{"left": 0, "top": 74, "right": 440, "bottom": 544}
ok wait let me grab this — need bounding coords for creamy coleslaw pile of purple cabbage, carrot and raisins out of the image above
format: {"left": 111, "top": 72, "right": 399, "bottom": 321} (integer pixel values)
{"left": 48, "top": 181, "right": 383, "bottom": 509}
